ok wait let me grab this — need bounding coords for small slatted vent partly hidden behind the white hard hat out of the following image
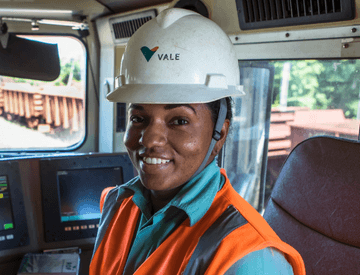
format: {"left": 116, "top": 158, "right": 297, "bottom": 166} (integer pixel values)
{"left": 109, "top": 10, "right": 156, "bottom": 44}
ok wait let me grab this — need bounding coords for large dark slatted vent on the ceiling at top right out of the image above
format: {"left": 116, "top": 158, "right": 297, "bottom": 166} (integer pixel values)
{"left": 236, "top": 0, "right": 355, "bottom": 30}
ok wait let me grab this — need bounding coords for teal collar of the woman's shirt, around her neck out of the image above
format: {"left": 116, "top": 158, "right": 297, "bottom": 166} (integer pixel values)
{"left": 118, "top": 160, "right": 223, "bottom": 226}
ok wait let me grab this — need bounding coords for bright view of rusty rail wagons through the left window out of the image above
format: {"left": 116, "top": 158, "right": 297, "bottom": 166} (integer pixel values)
{"left": 0, "top": 36, "right": 86, "bottom": 151}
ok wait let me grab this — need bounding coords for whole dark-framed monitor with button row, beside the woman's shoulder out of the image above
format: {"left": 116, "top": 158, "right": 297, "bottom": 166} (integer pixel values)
{"left": 40, "top": 154, "right": 134, "bottom": 242}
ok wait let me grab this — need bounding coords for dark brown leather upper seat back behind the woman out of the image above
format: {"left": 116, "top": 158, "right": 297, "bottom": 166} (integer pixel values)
{"left": 271, "top": 137, "right": 360, "bottom": 247}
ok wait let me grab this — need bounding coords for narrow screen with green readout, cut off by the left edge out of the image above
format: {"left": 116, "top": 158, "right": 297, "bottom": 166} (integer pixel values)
{"left": 0, "top": 176, "right": 14, "bottom": 231}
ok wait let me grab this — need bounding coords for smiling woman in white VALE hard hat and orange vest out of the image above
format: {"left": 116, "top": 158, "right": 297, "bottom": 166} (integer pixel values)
{"left": 90, "top": 9, "right": 305, "bottom": 275}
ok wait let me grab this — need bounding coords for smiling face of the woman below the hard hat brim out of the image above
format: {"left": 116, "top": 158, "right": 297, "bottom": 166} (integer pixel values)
{"left": 124, "top": 104, "right": 214, "bottom": 191}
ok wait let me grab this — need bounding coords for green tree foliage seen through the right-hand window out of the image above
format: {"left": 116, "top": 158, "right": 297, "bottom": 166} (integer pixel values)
{"left": 271, "top": 60, "right": 360, "bottom": 118}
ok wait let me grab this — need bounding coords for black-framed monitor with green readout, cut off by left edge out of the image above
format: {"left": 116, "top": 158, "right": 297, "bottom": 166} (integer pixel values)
{"left": 0, "top": 164, "right": 29, "bottom": 251}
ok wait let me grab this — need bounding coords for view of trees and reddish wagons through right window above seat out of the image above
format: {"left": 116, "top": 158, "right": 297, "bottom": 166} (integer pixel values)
{"left": 262, "top": 59, "right": 360, "bottom": 205}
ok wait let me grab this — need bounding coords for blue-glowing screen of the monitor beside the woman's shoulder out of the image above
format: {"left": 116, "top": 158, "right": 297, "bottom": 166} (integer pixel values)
{"left": 57, "top": 167, "right": 123, "bottom": 222}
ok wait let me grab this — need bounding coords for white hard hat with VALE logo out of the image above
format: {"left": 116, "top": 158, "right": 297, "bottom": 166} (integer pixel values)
{"left": 107, "top": 8, "right": 244, "bottom": 104}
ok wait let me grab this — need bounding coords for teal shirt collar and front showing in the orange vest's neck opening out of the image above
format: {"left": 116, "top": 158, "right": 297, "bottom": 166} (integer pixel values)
{"left": 118, "top": 161, "right": 225, "bottom": 275}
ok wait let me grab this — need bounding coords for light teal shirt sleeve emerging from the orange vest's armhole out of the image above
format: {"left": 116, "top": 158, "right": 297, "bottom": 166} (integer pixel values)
{"left": 225, "top": 247, "right": 294, "bottom": 275}
